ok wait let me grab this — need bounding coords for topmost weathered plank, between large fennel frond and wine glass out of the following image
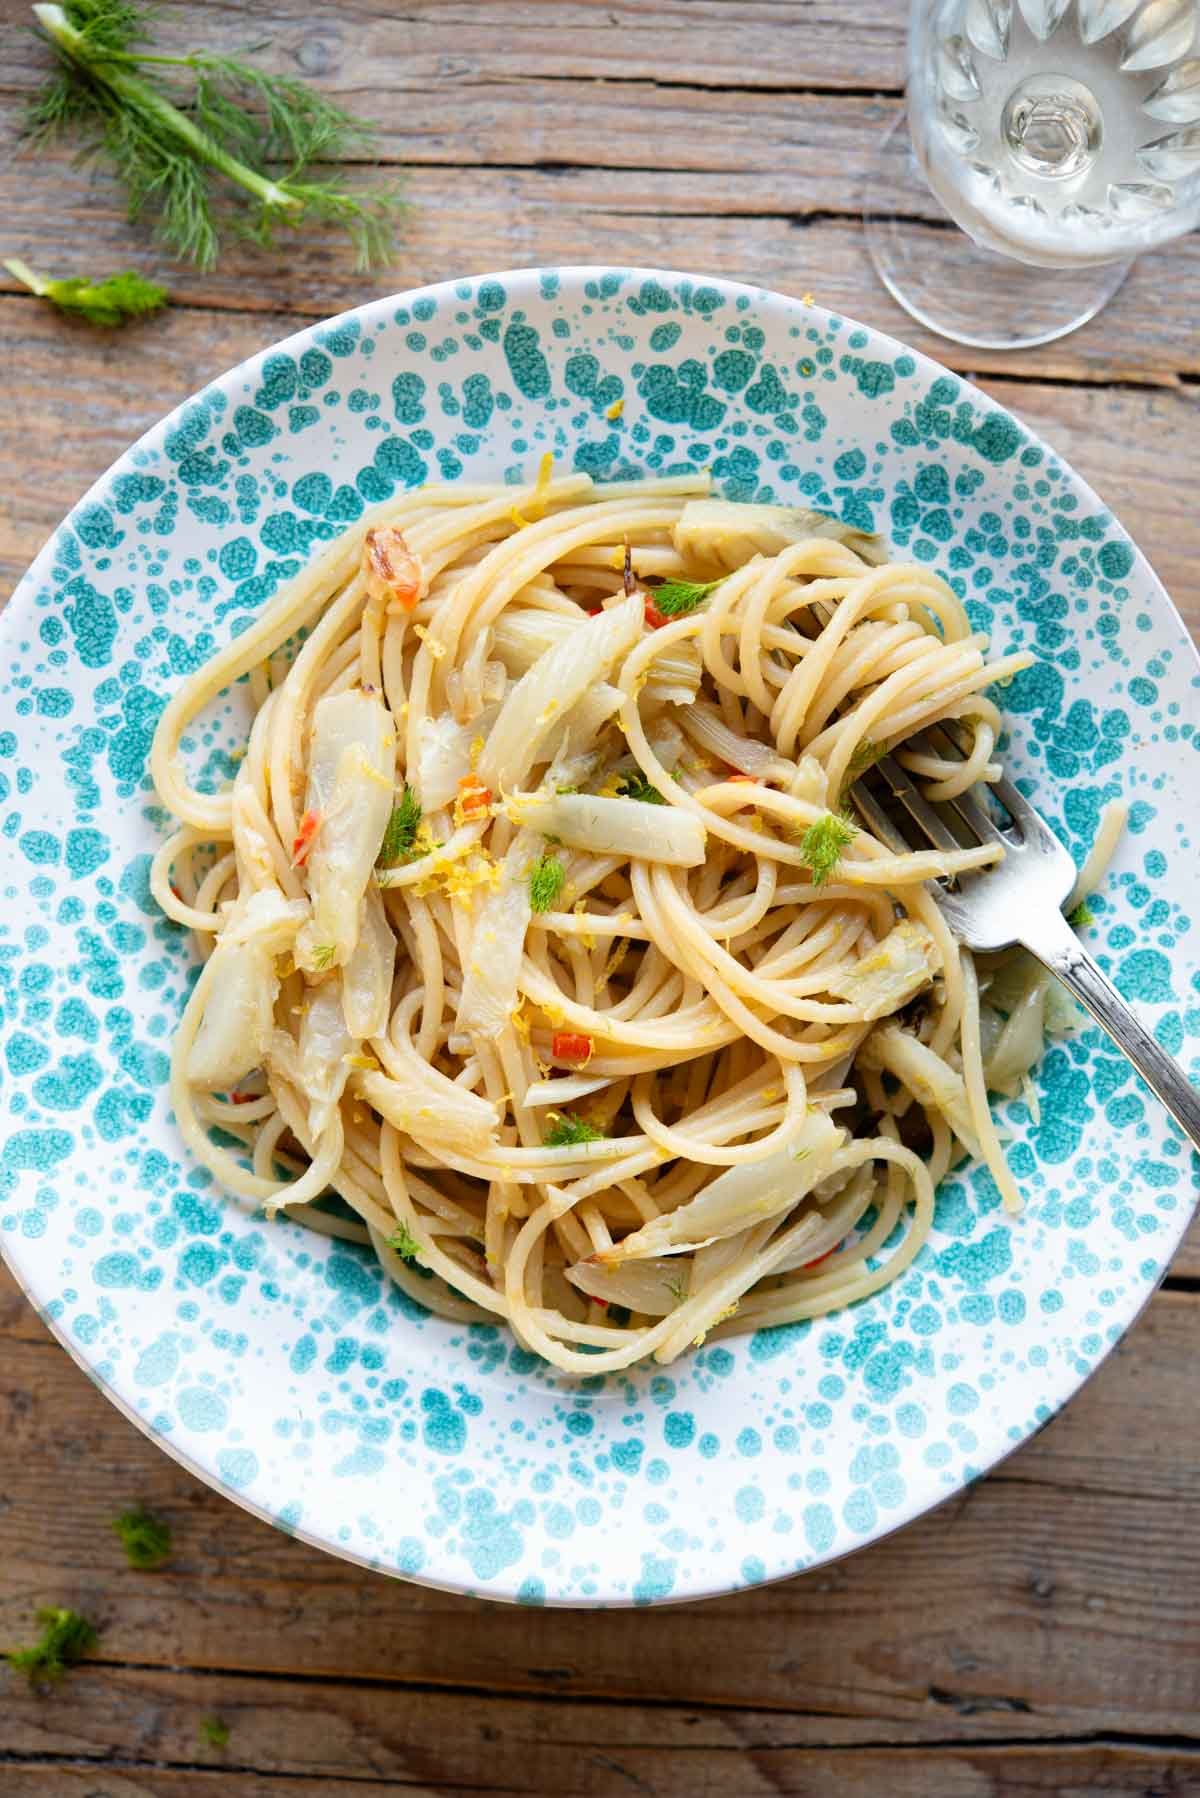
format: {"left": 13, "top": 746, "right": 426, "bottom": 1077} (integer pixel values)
{"left": 2, "top": 0, "right": 901, "bottom": 198}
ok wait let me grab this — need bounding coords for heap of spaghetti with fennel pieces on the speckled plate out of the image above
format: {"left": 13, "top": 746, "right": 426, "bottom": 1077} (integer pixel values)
{"left": 151, "top": 458, "right": 1040, "bottom": 1374}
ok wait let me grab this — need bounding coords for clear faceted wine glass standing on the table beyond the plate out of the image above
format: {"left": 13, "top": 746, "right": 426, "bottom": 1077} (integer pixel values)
{"left": 864, "top": 0, "right": 1200, "bottom": 349}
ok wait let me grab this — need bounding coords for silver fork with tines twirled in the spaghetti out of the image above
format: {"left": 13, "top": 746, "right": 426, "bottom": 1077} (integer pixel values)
{"left": 849, "top": 743, "right": 1200, "bottom": 1149}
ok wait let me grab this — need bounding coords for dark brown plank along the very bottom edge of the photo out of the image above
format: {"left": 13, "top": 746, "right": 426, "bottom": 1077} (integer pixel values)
{"left": 4, "top": 1667, "right": 1200, "bottom": 1798}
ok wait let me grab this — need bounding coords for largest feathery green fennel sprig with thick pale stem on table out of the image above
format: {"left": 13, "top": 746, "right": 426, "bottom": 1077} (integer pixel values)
{"left": 25, "top": 0, "right": 399, "bottom": 268}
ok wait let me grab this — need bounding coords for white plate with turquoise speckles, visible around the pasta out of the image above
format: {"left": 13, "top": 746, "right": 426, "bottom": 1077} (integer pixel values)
{"left": 0, "top": 270, "right": 1200, "bottom": 1604}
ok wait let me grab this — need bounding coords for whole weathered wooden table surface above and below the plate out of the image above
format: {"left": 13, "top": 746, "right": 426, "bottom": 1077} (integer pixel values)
{"left": 0, "top": 0, "right": 1200, "bottom": 1798}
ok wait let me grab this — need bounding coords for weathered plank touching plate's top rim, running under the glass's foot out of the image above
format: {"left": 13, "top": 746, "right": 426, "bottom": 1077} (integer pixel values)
{"left": 0, "top": 156, "right": 1200, "bottom": 383}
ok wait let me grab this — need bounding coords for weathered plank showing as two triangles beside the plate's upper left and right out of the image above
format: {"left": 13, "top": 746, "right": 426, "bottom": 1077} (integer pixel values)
{"left": 0, "top": 298, "right": 1200, "bottom": 647}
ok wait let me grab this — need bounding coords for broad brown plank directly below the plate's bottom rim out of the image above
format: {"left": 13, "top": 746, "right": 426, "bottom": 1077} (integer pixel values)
{"left": 0, "top": 1295, "right": 1200, "bottom": 1742}
